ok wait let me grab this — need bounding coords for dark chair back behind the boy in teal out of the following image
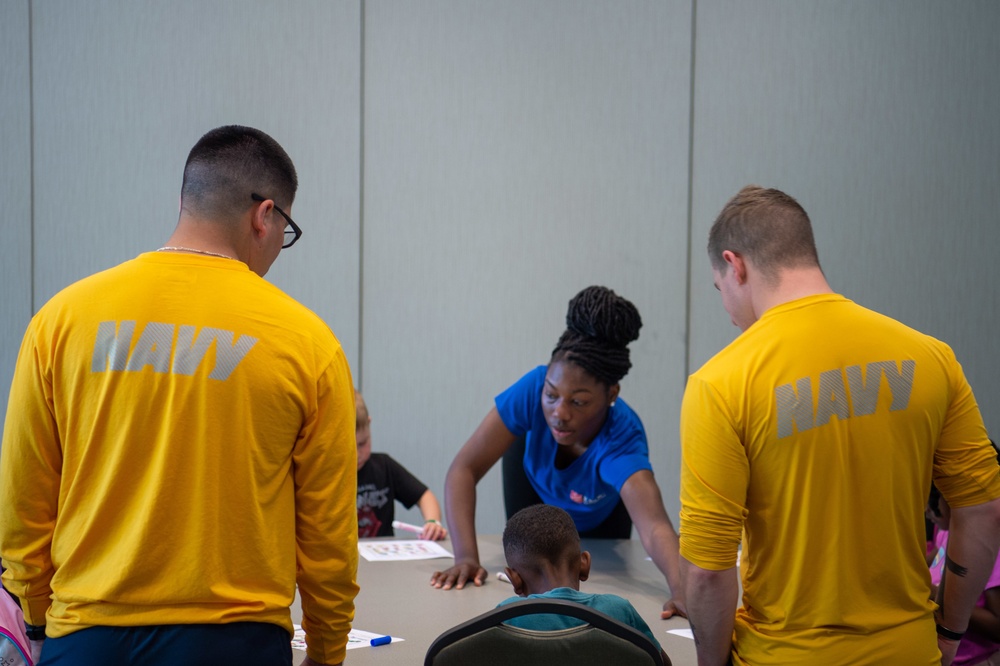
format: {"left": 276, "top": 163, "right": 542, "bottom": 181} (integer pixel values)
{"left": 424, "top": 599, "right": 670, "bottom": 666}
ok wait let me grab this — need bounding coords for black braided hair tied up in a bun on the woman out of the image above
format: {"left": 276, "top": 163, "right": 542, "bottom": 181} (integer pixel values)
{"left": 549, "top": 286, "right": 642, "bottom": 386}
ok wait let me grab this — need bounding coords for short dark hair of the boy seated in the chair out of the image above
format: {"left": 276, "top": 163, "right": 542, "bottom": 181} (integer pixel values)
{"left": 503, "top": 504, "right": 580, "bottom": 571}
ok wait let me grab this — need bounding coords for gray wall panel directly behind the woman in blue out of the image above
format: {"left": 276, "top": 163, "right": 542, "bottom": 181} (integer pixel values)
{"left": 363, "top": 0, "right": 691, "bottom": 532}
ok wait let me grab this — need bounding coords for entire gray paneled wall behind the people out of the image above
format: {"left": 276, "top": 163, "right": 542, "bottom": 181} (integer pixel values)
{"left": 0, "top": 0, "right": 1000, "bottom": 532}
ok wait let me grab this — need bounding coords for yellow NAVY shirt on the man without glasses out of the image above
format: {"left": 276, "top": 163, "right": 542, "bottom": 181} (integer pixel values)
{"left": 680, "top": 295, "right": 1000, "bottom": 666}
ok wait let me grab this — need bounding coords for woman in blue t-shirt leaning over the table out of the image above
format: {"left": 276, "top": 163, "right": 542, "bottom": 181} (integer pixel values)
{"left": 431, "top": 286, "right": 684, "bottom": 618}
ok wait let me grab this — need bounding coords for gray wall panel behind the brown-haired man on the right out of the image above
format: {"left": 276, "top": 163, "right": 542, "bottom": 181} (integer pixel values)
{"left": 690, "top": 0, "right": 1000, "bottom": 438}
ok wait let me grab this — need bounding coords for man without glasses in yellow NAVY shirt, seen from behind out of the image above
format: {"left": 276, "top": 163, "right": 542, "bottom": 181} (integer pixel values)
{"left": 680, "top": 186, "right": 1000, "bottom": 666}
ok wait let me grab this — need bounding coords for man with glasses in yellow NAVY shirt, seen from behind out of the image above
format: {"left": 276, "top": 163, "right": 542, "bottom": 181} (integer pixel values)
{"left": 0, "top": 126, "right": 358, "bottom": 666}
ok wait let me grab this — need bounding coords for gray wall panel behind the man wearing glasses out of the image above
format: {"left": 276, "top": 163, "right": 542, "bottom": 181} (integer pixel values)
{"left": 34, "top": 0, "right": 361, "bottom": 366}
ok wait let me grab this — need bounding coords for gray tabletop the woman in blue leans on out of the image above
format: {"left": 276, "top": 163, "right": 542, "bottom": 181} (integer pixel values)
{"left": 292, "top": 535, "right": 697, "bottom": 666}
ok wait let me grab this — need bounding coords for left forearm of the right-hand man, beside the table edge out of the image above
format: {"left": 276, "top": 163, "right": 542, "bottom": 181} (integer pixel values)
{"left": 680, "top": 557, "right": 739, "bottom": 666}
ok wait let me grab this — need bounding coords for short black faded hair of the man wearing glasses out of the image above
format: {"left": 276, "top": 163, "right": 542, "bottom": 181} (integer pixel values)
{"left": 181, "top": 125, "right": 299, "bottom": 223}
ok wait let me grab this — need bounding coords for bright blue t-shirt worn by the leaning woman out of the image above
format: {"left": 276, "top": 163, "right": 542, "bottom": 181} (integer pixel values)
{"left": 496, "top": 365, "right": 653, "bottom": 532}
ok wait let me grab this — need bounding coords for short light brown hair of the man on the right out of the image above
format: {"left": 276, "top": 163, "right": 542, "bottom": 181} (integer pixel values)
{"left": 708, "top": 185, "right": 819, "bottom": 281}
